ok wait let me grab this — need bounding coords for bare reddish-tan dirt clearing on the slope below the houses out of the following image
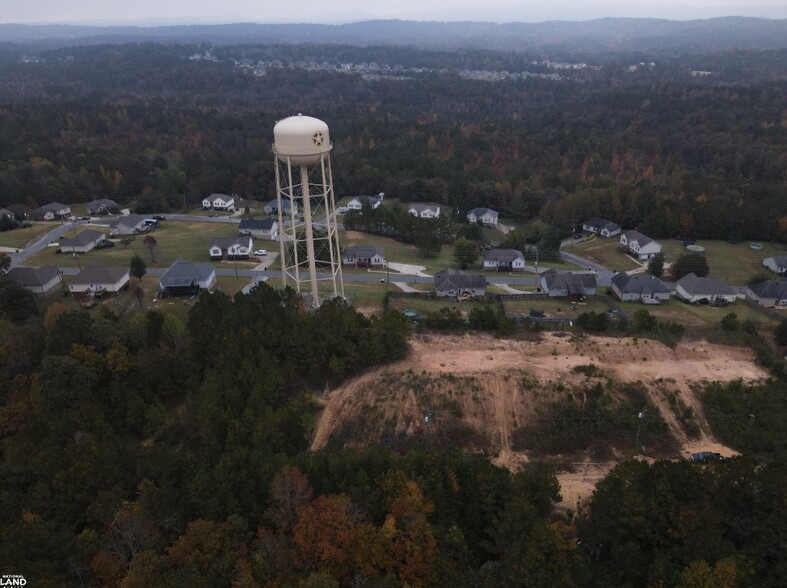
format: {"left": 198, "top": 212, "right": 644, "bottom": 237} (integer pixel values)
{"left": 312, "top": 333, "right": 767, "bottom": 508}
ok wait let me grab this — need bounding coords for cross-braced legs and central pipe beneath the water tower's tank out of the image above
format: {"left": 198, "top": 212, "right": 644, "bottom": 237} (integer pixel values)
{"left": 275, "top": 147, "right": 344, "bottom": 308}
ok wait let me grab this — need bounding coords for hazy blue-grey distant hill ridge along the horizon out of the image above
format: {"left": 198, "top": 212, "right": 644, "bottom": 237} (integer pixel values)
{"left": 0, "top": 17, "right": 787, "bottom": 51}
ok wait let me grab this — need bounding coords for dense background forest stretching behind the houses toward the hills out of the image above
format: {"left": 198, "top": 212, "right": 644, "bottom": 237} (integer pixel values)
{"left": 0, "top": 44, "right": 787, "bottom": 240}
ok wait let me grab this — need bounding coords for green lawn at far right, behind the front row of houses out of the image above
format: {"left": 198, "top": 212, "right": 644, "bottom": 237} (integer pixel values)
{"left": 660, "top": 239, "right": 787, "bottom": 286}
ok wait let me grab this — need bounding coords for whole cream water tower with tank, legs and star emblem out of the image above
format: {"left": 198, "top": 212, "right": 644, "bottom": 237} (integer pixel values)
{"left": 273, "top": 114, "right": 344, "bottom": 308}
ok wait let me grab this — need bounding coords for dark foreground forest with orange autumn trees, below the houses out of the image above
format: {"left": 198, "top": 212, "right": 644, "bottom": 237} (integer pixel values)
{"left": 0, "top": 277, "right": 787, "bottom": 588}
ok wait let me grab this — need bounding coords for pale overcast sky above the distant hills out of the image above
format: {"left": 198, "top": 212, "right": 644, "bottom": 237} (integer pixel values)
{"left": 0, "top": 0, "right": 787, "bottom": 26}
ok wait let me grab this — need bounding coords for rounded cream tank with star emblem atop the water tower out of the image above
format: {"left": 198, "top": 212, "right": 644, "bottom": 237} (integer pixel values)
{"left": 273, "top": 114, "right": 331, "bottom": 166}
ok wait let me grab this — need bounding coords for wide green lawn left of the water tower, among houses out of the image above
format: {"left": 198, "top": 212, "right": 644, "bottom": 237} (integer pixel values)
{"left": 25, "top": 222, "right": 251, "bottom": 268}
